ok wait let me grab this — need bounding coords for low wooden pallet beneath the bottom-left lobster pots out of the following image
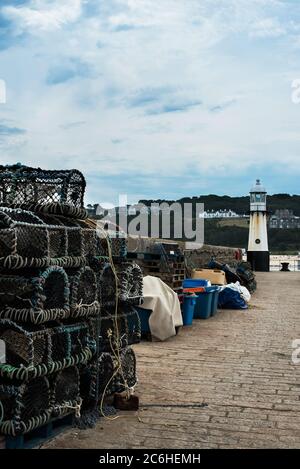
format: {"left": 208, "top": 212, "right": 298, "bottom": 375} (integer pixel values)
{"left": 5, "top": 414, "right": 74, "bottom": 449}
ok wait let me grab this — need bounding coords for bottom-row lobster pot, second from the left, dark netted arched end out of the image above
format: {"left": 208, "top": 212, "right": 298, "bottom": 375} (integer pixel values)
{"left": 51, "top": 366, "right": 81, "bottom": 416}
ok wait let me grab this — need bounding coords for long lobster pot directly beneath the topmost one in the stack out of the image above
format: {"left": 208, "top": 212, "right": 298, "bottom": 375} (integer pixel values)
{"left": 0, "top": 207, "right": 99, "bottom": 269}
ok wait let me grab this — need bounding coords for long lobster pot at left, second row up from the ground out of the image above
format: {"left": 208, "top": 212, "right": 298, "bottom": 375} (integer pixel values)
{"left": 0, "top": 319, "right": 96, "bottom": 372}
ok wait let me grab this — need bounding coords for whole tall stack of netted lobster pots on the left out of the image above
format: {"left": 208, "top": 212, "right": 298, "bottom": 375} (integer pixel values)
{"left": 0, "top": 164, "right": 142, "bottom": 436}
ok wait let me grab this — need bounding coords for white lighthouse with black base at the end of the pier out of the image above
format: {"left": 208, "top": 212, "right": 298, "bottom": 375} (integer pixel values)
{"left": 247, "top": 179, "right": 270, "bottom": 272}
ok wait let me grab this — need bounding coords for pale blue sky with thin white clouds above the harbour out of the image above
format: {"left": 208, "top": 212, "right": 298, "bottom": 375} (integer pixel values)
{"left": 0, "top": 0, "right": 300, "bottom": 204}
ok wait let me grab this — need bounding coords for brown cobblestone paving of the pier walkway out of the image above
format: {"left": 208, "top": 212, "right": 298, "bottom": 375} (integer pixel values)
{"left": 44, "top": 272, "right": 300, "bottom": 449}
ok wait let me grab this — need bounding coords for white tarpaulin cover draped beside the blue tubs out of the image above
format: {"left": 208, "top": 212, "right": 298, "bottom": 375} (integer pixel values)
{"left": 142, "top": 275, "right": 182, "bottom": 340}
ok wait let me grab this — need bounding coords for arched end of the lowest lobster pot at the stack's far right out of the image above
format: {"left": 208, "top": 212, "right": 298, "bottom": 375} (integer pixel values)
{"left": 113, "top": 347, "right": 137, "bottom": 392}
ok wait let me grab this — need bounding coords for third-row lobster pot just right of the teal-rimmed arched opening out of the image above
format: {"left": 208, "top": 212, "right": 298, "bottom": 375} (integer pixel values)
{"left": 69, "top": 267, "right": 100, "bottom": 318}
